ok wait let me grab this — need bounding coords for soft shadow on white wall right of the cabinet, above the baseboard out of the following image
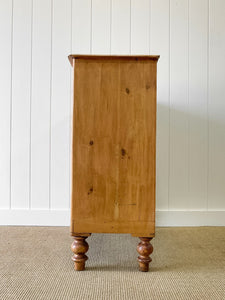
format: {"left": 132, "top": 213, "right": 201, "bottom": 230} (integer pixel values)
{"left": 156, "top": 99, "right": 225, "bottom": 210}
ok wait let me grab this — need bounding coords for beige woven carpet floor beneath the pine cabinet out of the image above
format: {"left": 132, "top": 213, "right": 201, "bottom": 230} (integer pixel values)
{"left": 0, "top": 226, "right": 225, "bottom": 300}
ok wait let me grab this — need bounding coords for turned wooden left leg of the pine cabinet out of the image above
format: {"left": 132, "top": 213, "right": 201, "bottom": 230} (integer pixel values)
{"left": 71, "top": 236, "right": 89, "bottom": 271}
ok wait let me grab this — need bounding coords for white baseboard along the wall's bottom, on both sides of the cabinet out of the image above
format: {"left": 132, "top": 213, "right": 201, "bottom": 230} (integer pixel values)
{"left": 0, "top": 209, "right": 225, "bottom": 227}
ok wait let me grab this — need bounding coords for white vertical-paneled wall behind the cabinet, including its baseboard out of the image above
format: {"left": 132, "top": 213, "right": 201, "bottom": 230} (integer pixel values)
{"left": 0, "top": 0, "right": 225, "bottom": 226}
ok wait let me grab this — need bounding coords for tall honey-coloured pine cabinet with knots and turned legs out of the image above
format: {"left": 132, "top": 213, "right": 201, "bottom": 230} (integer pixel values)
{"left": 69, "top": 55, "right": 159, "bottom": 271}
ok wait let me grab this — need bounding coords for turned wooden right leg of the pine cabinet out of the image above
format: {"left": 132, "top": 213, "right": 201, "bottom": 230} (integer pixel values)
{"left": 137, "top": 237, "right": 153, "bottom": 272}
